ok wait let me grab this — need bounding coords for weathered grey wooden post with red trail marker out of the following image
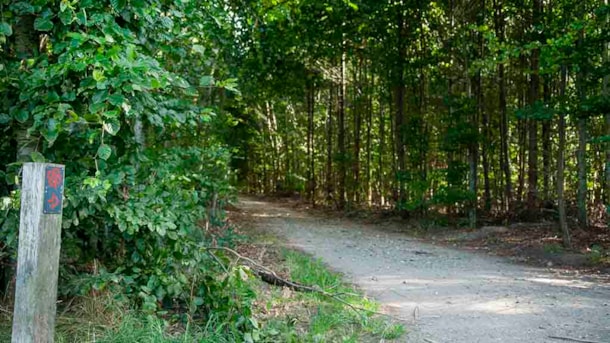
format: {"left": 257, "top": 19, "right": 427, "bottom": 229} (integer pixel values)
{"left": 12, "top": 163, "right": 64, "bottom": 343}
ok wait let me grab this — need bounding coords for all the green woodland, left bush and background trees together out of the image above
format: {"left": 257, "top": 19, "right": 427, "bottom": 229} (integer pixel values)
{"left": 0, "top": 0, "right": 610, "bottom": 342}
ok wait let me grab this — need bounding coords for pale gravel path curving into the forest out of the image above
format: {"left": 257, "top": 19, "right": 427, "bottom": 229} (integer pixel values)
{"left": 238, "top": 198, "right": 610, "bottom": 343}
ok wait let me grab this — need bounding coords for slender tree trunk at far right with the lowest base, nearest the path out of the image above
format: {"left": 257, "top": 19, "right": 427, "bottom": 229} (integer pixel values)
{"left": 557, "top": 66, "right": 572, "bottom": 248}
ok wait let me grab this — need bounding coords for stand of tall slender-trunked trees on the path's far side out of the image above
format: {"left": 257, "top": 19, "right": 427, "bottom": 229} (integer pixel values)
{"left": 229, "top": 0, "right": 610, "bottom": 247}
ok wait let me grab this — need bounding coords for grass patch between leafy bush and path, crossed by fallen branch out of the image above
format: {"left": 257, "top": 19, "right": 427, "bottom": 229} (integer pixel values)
{"left": 252, "top": 250, "right": 405, "bottom": 342}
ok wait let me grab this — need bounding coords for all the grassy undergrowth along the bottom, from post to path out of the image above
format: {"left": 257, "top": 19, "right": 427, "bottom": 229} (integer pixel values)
{"left": 0, "top": 250, "right": 405, "bottom": 343}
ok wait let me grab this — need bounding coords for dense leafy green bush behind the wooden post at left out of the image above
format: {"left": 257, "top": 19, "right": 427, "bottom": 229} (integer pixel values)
{"left": 0, "top": 0, "right": 258, "bottom": 342}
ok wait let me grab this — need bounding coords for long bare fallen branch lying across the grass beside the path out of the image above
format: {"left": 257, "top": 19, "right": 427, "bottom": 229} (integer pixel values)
{"left": 206, "top": 247, "right": 405, "bottom": 321}
